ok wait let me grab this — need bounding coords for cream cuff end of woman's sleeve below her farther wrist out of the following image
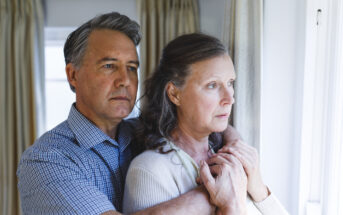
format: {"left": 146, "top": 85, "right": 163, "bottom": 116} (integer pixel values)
{"left": 254, "top": 193, "right": 289, "bottom": 215}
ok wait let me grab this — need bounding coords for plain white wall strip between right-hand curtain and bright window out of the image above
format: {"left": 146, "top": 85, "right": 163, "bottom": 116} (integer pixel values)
{"left": 261, "top": 0, "right": 306, "bottom": 214}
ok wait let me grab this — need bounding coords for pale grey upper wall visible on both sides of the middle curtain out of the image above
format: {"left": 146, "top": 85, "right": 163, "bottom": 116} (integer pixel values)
{"left": 45, "top": 0, "right": 226, "bottom": 39}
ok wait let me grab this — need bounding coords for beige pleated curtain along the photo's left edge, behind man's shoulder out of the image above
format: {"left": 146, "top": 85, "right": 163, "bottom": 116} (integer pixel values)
{"left": 0, "top": 0, "right": 44, "bottom": 214}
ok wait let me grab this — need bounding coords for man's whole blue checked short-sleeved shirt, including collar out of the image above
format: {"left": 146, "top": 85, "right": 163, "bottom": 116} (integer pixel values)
{"left": 17, "top": 105, "right": 141, "bottom": 214}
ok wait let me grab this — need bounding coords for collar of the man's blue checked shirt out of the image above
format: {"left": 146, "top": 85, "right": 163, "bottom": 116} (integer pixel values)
{"left": 67, "top": 103, "right": 121, "bottom": 149}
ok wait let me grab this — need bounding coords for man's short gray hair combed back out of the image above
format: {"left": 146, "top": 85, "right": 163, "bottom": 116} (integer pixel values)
{"left": 64, "top": 12, "right": 142, "bottom": 92}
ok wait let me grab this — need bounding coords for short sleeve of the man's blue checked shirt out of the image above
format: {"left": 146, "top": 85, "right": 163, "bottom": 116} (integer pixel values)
{"left": 17, "top": 149, "right": 115, "bottom": 214}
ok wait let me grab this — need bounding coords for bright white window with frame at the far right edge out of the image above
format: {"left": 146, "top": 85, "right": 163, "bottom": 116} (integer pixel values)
{"left": 299, "top": 0, "right": 343, "bottom": 215}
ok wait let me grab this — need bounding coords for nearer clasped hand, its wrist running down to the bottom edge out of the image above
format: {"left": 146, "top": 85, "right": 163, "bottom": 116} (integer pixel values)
{"left": 200, "top": 156, "right": 247, "bottom": 215}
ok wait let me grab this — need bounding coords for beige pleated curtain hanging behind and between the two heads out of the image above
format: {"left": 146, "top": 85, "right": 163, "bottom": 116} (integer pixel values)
{"left": 137, "top": 0, "right": 200, "bottom": 92}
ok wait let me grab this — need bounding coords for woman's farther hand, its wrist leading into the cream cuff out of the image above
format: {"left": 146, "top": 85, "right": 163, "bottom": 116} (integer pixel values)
{"left": 218, "top": 140, "right": 269, "bottom": 202}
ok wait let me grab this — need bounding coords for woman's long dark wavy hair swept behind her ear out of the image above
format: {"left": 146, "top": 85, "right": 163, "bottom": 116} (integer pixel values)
{"left": 136, "top": 33, "right": 227, "bottom": 149}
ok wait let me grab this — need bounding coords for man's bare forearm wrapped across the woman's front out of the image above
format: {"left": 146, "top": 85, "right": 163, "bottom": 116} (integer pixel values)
{"left": 103, "top": 186, "right": 214, "bottom": 215}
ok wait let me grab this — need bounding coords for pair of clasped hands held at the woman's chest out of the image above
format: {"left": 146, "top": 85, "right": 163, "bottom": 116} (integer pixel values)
{"left": 199, "top": 140, "right": 269, "bottom": 215}
